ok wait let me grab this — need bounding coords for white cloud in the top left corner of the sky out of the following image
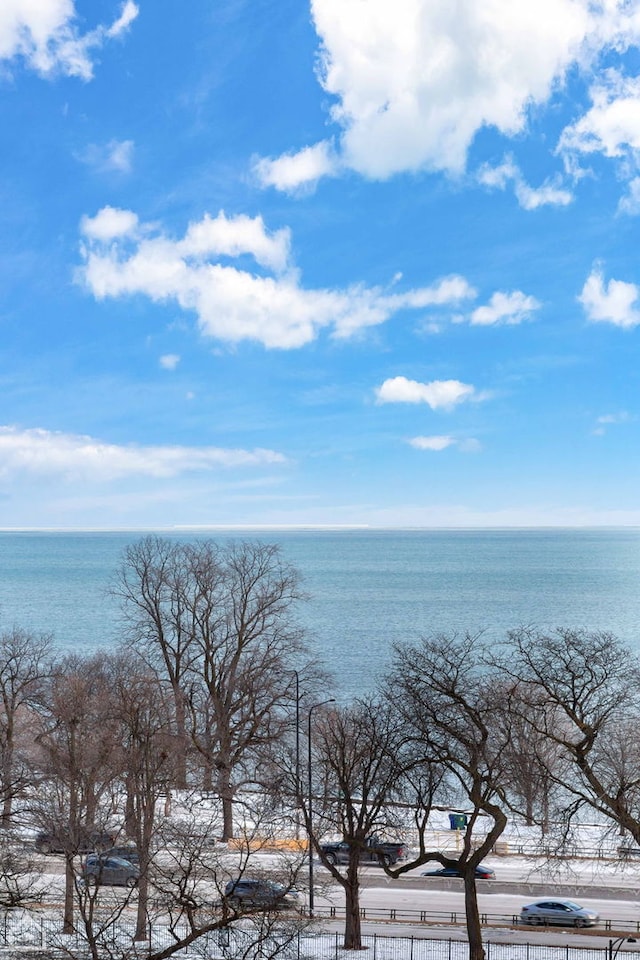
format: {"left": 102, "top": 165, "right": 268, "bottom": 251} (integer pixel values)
{"left": 0, "top": 0, "right": 138, "bottom": 80}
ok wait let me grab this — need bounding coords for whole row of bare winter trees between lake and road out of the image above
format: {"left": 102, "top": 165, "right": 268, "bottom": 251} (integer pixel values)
{"left": 0, "top": 537, "right": 640, "bottom": 960}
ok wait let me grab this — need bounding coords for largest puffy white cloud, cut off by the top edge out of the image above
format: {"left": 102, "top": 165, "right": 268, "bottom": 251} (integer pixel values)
{"left": 254, "top": 0, "right": 638, "bottom": 188}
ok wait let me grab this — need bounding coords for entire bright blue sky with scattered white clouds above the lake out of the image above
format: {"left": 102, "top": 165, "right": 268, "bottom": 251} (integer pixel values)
{"left": 0, "top": 0, "right": 640, "bottom": 528}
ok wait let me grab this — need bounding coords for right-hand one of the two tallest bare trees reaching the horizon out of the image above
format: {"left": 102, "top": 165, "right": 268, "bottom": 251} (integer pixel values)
{"left": 189, "top": 542, "right": 305, "bottom": 840}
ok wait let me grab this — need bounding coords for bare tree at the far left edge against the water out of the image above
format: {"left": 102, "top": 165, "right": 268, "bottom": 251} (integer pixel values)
{"left": 0, "top": 627, "right": 52, "bottom": 829}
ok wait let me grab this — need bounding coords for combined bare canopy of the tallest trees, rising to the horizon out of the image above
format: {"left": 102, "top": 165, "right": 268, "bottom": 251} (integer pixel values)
{"left": 114, "top": 537, "right": 306, "bottom": 839}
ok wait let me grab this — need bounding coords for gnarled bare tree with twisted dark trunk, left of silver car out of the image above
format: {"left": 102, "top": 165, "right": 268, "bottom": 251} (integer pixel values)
{"left": 390, "top": 634, "right": 509, "bottom": 960}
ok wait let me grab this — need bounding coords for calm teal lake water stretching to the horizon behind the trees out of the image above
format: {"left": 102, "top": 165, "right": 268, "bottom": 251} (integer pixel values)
{"left": 0, "top": 529, "right": 640, "bottom": 692}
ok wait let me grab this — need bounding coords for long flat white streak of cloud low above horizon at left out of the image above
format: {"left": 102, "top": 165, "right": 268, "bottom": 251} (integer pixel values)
{"left": 0, "top": 426, "right": 285, "bottom": 481}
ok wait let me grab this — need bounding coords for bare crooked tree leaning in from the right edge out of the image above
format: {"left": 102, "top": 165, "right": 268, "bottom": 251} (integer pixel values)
{"left": 494, "top": 628, "right": 640, "bottom": 844}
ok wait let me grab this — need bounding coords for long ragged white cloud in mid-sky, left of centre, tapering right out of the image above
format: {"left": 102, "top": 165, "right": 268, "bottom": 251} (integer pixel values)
{"left": 79, "top": 207, "right": 475, "bottom": 349}
